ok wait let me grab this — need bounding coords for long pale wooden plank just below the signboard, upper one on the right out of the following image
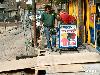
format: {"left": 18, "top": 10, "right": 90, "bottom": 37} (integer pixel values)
{"left": 37, "top": 52, "right": 100, "bottom": 66}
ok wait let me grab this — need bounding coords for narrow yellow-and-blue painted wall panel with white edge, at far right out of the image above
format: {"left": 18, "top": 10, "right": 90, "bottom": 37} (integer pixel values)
{"left": 88, "top": 0, "right": 96, "bottom": 47}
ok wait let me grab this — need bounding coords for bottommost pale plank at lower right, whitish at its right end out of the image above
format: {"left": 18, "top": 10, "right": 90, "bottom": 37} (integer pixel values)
{"left": 35, "top": 63, "right": 100, "bottom": 73}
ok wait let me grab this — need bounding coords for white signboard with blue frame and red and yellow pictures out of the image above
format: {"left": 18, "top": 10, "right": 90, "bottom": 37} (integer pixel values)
{"left": 59, "top": 25, "right": 77, "bottom": 48}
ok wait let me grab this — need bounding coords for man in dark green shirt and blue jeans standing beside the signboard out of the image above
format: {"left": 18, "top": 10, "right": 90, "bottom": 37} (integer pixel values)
{"left": 41, "top": 5, "right": 57, "bottom": 50}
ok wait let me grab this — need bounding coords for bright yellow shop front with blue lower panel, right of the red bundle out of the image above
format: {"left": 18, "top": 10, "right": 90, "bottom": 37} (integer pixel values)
{"left": 69, "top": 0, "right": 96, "bottom": 47}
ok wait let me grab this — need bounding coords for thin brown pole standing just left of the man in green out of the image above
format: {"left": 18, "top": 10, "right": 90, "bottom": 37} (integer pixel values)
{"left": 32, "top": 0, "right": 37, "bottom": 47}
